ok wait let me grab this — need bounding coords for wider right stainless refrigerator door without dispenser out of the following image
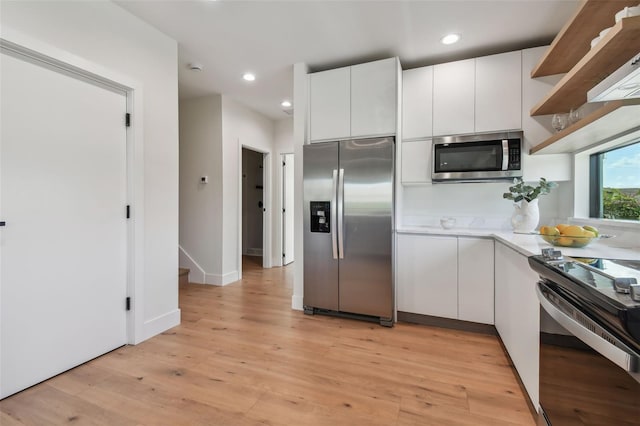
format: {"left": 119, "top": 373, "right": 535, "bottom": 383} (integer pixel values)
{"left": 338, "top": 138, "right": 394, "bottom": 318}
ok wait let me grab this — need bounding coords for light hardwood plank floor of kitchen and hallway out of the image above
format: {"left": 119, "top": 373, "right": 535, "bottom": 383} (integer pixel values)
{"left": 0, "top": 258, "right": 535, "bottom": 426}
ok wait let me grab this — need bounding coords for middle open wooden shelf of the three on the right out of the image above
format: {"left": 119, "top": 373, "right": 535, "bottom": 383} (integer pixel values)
{"left": 531, "top": 16, "right": 640, "bottom": 116}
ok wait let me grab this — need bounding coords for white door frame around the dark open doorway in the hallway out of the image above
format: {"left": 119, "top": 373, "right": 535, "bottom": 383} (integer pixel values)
{"left": 237, "top": 143, "right": 273, "bottom": 280}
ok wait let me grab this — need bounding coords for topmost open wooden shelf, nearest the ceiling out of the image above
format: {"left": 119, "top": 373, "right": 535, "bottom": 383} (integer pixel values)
{"left": 531, "top": 0, "right": 638, "bottom": 78}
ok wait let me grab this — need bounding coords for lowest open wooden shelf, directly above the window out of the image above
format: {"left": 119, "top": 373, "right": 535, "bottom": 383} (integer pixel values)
{"left": 529, "top": 99, "right": 640, "bottom": 155}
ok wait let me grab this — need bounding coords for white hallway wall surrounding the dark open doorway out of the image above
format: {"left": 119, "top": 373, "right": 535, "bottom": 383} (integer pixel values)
{"left": 222, "top": 95, "right": 280, "bottom": 282}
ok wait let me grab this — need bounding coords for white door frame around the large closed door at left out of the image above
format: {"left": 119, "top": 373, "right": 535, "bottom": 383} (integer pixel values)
{"left": 0, "top": 28, "right": 145, "bottom": 344}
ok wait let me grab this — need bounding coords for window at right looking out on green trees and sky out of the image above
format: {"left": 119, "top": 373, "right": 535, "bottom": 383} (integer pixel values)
{"left": 589, "top": 142, "right": 640, "bottom": 220}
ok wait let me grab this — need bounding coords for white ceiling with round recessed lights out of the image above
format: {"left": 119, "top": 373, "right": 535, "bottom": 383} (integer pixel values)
{"left": 116, "top": 0, "right": 579, "bottom": 120}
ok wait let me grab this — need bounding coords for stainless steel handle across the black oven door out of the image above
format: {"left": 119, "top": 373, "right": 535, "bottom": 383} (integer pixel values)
{"left": 536, "top": 282, "right": 640, "bottom": 381}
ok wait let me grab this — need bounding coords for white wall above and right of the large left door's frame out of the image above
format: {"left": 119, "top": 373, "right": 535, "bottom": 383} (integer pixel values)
{"left": 0, "top": 1, "right": 180, "bottom": 339}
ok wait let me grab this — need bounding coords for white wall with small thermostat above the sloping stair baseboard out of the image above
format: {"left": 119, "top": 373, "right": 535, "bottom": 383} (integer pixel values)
{"left": 180, "top": 95, "right": 223, "bottom": 283}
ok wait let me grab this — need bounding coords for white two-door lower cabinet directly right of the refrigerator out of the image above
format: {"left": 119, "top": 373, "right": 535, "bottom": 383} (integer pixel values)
{"left": 396, "top": 234, "right": 493, "bottom": 324}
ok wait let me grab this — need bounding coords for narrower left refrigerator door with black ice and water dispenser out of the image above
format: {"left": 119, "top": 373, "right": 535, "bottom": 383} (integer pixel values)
{"left": 303, "top": 142, "right": 339, "bottom": 311}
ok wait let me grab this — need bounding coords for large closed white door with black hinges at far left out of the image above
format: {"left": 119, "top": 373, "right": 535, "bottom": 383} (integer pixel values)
{"left": 0, "top": 53, "right": 127, "bottom": 397}
